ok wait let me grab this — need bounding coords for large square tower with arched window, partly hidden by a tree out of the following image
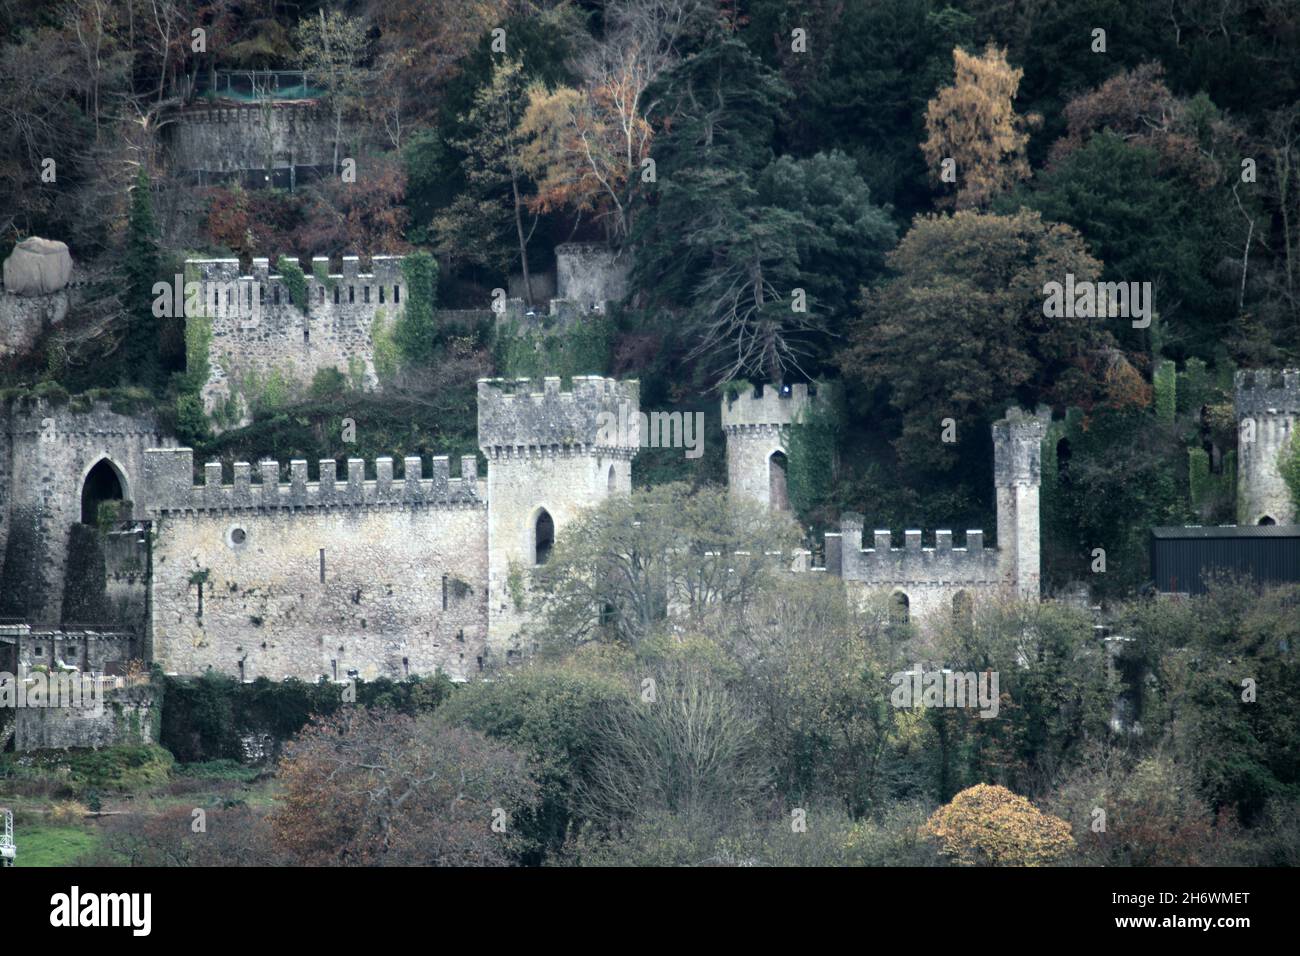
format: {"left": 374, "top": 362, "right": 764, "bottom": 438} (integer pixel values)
{"left": 478, "top": 376, "right": 641, "bottom": 657}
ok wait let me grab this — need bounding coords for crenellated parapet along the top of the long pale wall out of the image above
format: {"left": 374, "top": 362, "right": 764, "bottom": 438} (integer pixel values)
{"left": 140, "top": 449, "right": 484, "bottom": 516}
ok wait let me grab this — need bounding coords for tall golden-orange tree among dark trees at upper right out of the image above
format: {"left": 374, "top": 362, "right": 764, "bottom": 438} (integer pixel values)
{"left": 920, "top": 44, "right": 1039, "bottom": 209}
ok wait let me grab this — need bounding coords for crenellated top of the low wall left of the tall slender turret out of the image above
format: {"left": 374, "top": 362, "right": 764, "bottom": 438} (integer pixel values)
{"left": 826, "top": 514, "right": 1000, "bottom": 585}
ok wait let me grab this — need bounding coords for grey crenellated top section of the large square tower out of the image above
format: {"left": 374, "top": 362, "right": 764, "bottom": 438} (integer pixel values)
{"left": 478, "top": 375, "right": 641, "bottom": 457}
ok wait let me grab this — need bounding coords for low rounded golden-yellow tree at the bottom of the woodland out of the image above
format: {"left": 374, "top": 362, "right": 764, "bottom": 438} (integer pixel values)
{"left": 922, "top": 783, "right": 1074, "bottom": 866}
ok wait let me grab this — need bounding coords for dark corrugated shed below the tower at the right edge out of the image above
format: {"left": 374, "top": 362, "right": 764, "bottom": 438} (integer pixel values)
{"left": 1151, "top": 524, "right": 1300, "bottom": 594}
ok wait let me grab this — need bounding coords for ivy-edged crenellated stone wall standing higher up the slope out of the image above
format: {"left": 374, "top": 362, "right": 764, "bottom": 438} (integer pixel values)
{"left": 187, "top": 256, "right": 407, "bottom": 421}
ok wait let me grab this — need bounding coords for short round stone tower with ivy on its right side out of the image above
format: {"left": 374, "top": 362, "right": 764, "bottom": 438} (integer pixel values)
{"left": 723, "top": 384, "right": 818, "bottom": 511}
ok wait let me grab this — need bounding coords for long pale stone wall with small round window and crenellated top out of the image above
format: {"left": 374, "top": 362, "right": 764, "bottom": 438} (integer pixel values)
{"left": 147, "top": 449, "right": 490, "bottom": 680}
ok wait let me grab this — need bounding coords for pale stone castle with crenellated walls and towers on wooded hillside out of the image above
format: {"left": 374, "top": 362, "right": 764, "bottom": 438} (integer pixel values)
{"left": 0, "top": 239, "right": 1300, "bottom": 740}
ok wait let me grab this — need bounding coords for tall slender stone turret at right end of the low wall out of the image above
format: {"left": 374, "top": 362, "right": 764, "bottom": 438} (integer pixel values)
{"left": 993, "top": 408, "right": 1052, "bottom": 600}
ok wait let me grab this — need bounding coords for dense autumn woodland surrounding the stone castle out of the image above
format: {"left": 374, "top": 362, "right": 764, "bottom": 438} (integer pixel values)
{"left": 0, "top": 0, "right": 1300, "bottom": 865}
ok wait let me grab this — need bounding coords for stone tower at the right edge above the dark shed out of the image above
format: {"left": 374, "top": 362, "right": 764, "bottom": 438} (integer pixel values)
{"left": 1236, "top": 368, "right": 1300, "bottom": 524}
